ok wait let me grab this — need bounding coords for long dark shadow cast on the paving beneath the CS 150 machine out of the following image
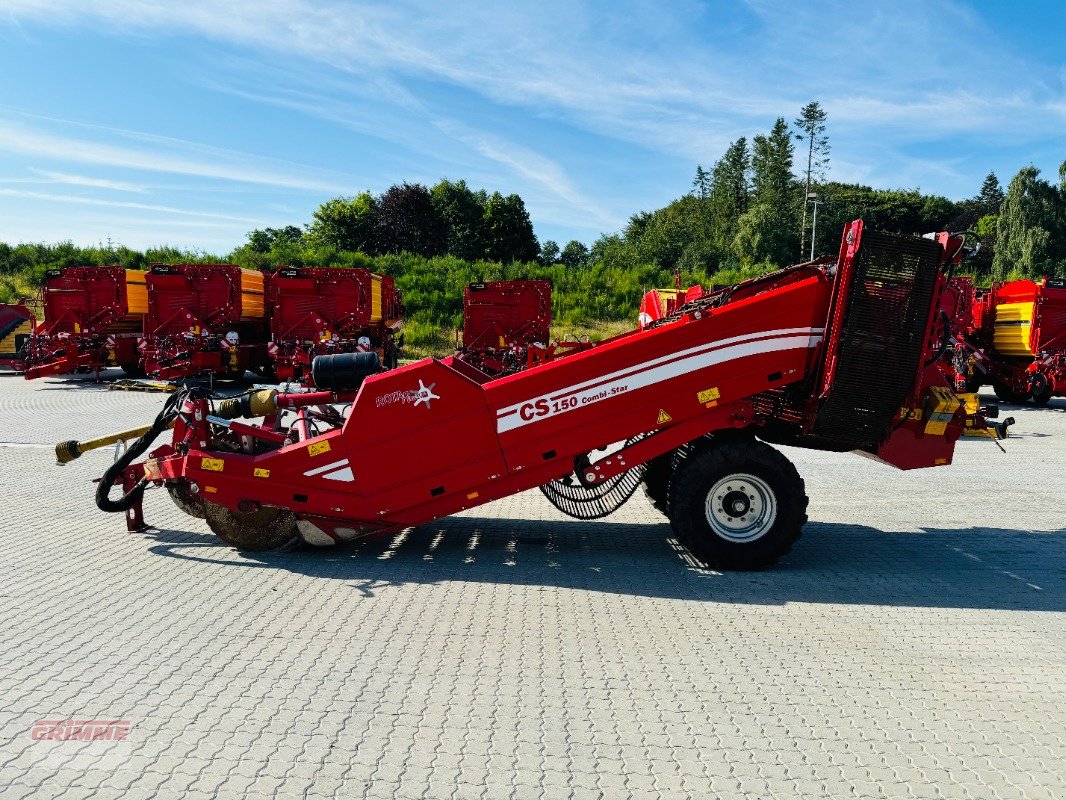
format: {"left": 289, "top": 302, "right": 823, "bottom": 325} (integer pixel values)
{"left": 147, "top": 516, "right": 1066, "bottom": 611}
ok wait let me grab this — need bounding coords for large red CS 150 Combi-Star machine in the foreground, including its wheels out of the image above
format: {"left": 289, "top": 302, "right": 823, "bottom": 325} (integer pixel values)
{"left": 70, "top": 221, "right": 984, "bottom": 569}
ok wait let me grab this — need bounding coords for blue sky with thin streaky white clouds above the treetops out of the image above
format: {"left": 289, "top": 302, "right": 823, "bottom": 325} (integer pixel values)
{"left": 0, "top": 0, "right": 1066, "bottom": 253}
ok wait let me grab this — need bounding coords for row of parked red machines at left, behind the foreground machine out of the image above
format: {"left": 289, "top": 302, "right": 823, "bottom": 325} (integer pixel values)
{"left": 0, "top": 263, "right": 403, "bottom": 382}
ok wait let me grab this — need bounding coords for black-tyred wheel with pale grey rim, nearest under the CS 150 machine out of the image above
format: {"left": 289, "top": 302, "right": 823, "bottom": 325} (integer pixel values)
{"left": 669, "top": 438, "right": 807, "bottom": 570}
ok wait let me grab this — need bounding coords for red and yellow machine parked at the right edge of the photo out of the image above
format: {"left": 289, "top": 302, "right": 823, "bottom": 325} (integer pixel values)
{"left": 955, "top": 278, "right": 1066, "bottom": 405}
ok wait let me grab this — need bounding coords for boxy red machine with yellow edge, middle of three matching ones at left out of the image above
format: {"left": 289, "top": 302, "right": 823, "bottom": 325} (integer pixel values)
{"left": 140, "top": 263, "right": 270, "bottom": 380}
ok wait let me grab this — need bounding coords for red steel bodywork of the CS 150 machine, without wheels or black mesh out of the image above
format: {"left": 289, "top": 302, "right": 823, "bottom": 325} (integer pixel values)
{"left": 126, "top": 223, "right": 965, "bottom": 544}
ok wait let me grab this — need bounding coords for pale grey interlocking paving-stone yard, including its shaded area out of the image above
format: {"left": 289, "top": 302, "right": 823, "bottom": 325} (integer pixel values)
{"left": 0, "top": 377, "right": 1066, "bottom": 800}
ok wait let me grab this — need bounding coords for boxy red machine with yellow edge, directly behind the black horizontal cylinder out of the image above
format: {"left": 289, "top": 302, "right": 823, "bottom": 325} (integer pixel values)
{"left": 268, "top": 267, "right": 403, "bottom": 383}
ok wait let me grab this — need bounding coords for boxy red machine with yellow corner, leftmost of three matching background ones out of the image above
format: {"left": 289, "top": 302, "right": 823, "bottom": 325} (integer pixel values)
{"left": 25, "top": 267, "right": 148, "bottom": 380}
